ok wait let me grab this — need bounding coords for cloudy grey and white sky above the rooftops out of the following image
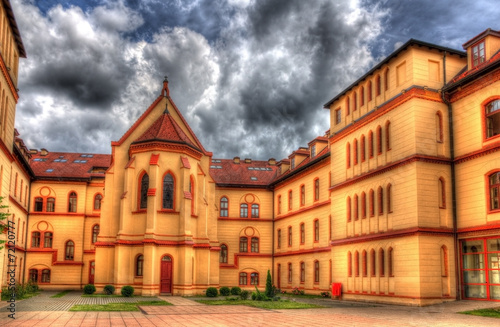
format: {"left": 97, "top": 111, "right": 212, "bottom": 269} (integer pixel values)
{"left": 11, "top": 0, "right": 500, "bottom": 160}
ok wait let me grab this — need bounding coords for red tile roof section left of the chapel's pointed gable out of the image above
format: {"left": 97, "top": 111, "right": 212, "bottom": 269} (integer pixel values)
{"left": 30, "top": 152, "right": 111, "bottom": 179}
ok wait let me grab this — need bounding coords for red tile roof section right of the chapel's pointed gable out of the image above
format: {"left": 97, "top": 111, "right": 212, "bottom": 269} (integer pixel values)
{"left": 210, "top": 159, "right": 278, "bottom": 187}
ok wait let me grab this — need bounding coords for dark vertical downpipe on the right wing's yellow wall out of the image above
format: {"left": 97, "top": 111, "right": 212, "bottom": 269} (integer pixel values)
{"left": 441, "top": 51, "right": 462, "bottom": 300}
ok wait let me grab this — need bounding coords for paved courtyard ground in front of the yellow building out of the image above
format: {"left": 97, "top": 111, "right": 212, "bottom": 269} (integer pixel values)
{"left": 0, "top": 292, "right": 500, "bottom": 327}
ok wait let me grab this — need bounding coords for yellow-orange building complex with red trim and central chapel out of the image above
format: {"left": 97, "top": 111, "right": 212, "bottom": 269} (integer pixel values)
{"left": 0, "top": 1, "right": 500, "bottom": 305}
